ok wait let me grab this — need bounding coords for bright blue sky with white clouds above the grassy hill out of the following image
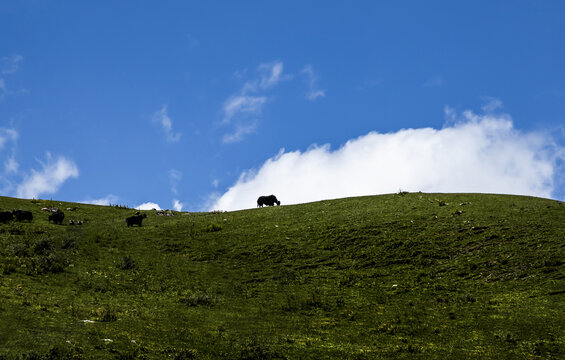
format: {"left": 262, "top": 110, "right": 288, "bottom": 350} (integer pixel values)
{"left": 0, "top": 0, "right": 565, "bottom": 211}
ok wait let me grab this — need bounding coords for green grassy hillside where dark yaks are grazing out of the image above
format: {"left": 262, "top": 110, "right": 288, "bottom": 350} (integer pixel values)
{"left": 0, "top": 193, "right": 565, "bottom": 359}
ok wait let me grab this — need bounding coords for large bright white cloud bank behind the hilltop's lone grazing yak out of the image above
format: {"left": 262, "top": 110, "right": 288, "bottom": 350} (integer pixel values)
{"left": 210, "top": 110, "right": 565, "bottom": 210}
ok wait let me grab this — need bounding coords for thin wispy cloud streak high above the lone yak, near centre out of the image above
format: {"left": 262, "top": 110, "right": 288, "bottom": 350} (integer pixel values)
{"left": 222, "top": 60, "right": 291, "bottom": 143}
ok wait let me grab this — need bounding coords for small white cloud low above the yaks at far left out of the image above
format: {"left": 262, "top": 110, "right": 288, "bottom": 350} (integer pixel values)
{"left": 17, "top": 153, "right": 79, "bottom": 199}
